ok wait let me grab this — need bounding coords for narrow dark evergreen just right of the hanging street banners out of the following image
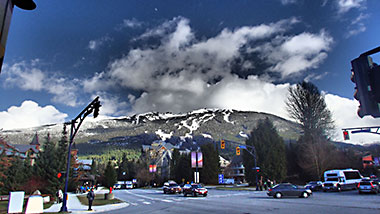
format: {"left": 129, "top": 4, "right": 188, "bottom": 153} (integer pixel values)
{"left": 200, "top": 143, "right": 220, "bottom": 184}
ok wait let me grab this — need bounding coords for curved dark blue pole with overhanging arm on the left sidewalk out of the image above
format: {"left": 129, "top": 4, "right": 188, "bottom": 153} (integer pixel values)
{"left": 59, "top": 97, "right": 101, "bottom": 212}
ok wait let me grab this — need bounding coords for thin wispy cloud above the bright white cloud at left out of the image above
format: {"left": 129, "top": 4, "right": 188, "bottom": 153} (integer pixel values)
{"left": 3, "top": 61, "right": 81, "bottom": 107}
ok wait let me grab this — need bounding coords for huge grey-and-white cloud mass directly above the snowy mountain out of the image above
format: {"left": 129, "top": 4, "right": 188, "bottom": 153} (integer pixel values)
{"left": 83, "top": 17, "right": 332, "bottom": 117}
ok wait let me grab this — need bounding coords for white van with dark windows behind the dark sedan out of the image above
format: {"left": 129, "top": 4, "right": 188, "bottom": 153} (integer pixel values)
{"left": 322, "top": 169, "right": 363, "bottom": 192}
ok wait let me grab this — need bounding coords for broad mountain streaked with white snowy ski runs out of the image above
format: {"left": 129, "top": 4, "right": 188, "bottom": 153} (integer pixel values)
{"left": 2, "top": 109, "right": 301, "bottom": 152}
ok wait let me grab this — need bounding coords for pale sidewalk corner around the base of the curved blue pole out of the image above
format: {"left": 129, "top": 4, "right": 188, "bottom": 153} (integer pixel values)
{"left": 44, "top": 190, "right": 129, "bottom": 213}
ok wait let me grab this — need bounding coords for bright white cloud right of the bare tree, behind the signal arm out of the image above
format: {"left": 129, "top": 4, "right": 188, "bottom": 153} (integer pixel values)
{"left": 325, "top": 94, "right": 380, "bottom": 144}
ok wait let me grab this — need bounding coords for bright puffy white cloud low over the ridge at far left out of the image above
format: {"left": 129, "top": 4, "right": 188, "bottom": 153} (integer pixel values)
{"left": 0, "top": 100, "right": 67, "bottom": 130}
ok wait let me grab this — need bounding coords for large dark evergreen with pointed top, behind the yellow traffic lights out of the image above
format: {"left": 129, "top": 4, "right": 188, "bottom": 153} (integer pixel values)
{"left": 243, "top": 118, "right": 287, "bottom": 184}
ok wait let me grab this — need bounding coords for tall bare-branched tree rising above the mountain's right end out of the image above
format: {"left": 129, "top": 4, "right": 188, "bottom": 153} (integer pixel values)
{"left": 286, "top": 82, "right": 334, "bottom": 179}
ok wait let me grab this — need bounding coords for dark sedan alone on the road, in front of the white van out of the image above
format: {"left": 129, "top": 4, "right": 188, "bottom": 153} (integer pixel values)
{"left": 267, "top": 183, "right": 313, "bottom": 198}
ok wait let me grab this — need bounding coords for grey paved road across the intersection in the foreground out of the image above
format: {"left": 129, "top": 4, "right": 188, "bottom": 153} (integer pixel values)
{"left": 100, "top": 189, "right": 380, "bottom": 214}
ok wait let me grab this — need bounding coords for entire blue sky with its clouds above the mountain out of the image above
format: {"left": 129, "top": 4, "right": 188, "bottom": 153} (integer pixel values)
{"left": 0, "top": 0, "right": 380, "bottom": 143}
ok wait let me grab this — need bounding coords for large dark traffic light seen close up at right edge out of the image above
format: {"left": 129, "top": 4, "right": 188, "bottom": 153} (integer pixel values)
{"left": 351, "top": 47, "right": 380, "bottom": 118}
